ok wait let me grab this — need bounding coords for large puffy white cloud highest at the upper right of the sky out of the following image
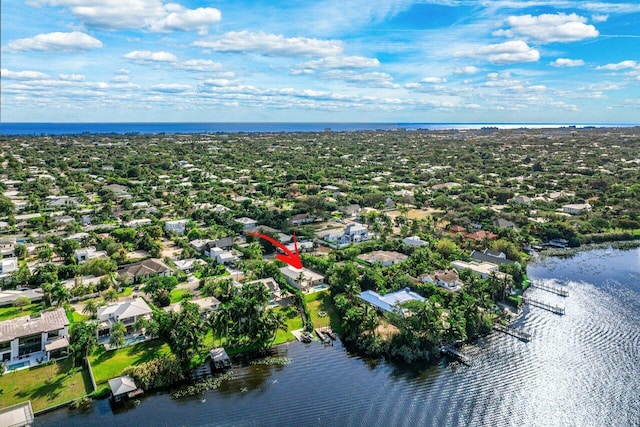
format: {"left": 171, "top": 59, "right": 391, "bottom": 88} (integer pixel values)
{"left": 493, "top": 13, "right": 600, "bottom": 43}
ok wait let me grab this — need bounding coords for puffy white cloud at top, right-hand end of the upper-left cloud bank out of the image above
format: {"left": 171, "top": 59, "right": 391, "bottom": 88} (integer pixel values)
{"left": 149, "top": 4, "right": 222, "bottom": 33}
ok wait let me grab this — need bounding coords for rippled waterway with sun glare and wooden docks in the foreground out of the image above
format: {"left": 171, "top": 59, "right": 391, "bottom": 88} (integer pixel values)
{"left": 36, "top": 249, "right": 640, "bottom": 427}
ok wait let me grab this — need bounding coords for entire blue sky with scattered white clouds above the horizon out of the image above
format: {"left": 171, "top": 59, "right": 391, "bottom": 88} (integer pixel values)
{"left": 0, "top": 0, "right": 640, "bottom": 123}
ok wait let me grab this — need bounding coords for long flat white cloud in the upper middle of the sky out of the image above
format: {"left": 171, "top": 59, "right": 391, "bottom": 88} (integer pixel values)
{"left": 193, "top": 30, "right": 342, "bottom": 56}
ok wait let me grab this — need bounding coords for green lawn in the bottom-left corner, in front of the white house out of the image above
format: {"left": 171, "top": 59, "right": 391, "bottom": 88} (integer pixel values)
{"left": 0, "top": 358, "right": 93, "bottom": 411}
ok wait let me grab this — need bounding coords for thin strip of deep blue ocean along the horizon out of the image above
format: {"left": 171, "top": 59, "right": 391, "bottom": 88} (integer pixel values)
{"left": 0, "top": 123, "right": 638, "bottom": 135}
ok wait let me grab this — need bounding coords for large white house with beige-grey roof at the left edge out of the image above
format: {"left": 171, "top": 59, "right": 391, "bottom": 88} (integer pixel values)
{"left": 0, "top": 308, "right": 69, "bottom": 370}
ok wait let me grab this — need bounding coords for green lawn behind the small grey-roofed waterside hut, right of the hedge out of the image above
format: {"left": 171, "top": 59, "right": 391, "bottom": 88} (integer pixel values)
{"left": 89, "top": 339, "right": 171, "bottom": 388}
